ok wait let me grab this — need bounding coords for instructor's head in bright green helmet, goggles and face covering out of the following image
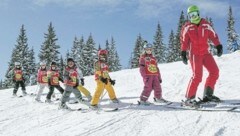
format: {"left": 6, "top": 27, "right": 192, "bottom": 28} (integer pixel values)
{"left": 187, "top": 5, "right": 201, "bottom": 24}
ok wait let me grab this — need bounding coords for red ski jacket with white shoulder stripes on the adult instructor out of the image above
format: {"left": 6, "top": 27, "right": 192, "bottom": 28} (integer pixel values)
{"left": 180, "top": 18, "right": 220, "bottom": 55}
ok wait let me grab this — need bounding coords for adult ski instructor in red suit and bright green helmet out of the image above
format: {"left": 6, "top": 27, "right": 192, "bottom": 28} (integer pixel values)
{"left": 180, "top": 5, "right": 223, "bottom": 106}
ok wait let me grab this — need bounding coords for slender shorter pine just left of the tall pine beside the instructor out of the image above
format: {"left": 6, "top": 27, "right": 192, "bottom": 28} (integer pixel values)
{"left": 166, "top": 30, "right": 176, "bottom": 62}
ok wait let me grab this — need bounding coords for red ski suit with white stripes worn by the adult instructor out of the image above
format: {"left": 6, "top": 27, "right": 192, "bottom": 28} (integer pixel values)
{"left": 180, "top": 19, "right": 220, "bottom": 98}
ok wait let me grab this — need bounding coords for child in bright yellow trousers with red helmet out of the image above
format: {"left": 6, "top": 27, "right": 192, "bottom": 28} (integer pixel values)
{"left": 91, "top": 50, "right": 119, "bottom": 109}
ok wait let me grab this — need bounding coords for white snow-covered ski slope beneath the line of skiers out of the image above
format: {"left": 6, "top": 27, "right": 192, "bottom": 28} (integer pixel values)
{"left": 0, "top": 51, "right": 240, "bottom": 136}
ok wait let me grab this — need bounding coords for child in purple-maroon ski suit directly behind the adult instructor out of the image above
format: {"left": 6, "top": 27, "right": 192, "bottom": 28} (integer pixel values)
{"left": 139, "top": 43, "right": 168, "bottom": 105}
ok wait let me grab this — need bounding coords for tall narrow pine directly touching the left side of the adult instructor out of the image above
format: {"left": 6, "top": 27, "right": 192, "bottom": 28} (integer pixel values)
{"left": 173, "top": 11, "right": 186, "bottom": 61}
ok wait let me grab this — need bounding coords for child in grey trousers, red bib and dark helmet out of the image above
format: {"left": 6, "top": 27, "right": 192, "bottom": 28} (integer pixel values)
{"left": 59, "top": 58, "right": 87, "bottom": 109}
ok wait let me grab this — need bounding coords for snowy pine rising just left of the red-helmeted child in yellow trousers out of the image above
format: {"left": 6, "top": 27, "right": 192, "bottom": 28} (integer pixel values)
{"left": 82, "top": 34, "right": 97, "bottom": 76}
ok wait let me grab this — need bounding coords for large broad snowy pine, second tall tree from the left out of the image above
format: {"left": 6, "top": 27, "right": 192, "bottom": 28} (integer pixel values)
{"left": 38, "top": 22, "right": 60, "bottom": 66}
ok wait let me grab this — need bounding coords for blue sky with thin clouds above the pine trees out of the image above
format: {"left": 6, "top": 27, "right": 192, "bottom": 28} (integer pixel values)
{"left": 0, "top": 0, "right": 240, "bottom": 79}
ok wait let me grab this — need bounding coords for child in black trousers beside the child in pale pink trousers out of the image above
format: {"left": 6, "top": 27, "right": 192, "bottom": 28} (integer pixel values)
{"left": 45, "top": 62, "right": 64, "bottom": 103}
